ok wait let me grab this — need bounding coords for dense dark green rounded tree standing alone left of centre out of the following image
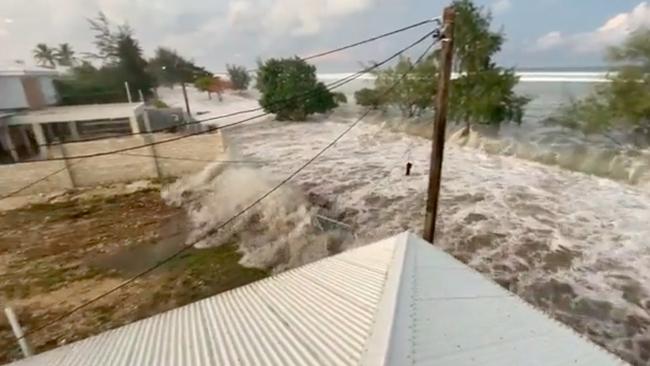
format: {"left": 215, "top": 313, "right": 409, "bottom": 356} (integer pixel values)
{"left": 256, "top": 57, "right": 337, "bottom": 121}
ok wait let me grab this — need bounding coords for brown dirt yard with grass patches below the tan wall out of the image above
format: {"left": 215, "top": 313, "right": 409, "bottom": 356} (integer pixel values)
{"left": 0, "top": 188, "right": 267, "bottom": 364}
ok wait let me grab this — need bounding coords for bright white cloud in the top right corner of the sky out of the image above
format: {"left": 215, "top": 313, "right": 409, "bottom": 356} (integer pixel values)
{"left": 530, "top": 1, "right": 650, "bottom": 53}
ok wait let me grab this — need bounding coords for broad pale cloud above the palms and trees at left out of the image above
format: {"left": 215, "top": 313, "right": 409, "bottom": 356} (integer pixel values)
{"left": 0, "top": 0, "right": 379, "bottom": 69}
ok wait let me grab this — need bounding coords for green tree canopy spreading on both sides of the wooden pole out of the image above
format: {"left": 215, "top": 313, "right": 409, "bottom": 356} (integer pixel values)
{"left": 357, "top": 0, "right": 529, "bottom": 128}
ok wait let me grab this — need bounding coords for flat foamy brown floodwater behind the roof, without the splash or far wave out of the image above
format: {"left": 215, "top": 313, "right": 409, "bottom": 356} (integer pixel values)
{"left": 214, "top": 118, "right": 650, "bottom": 364}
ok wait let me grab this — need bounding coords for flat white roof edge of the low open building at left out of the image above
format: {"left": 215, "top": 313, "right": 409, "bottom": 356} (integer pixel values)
{"left": 9, "top": 103, "right": 144, "bottom": 125}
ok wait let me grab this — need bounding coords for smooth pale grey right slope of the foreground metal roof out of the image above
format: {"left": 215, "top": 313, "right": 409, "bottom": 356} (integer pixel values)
{"left": 364, "top": 234, "right": 626, "bottom": 366}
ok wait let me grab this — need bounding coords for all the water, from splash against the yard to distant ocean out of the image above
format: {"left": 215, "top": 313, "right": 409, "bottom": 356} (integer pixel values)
{"left": 166, "top": 73, "right": 650, "bottom": 365}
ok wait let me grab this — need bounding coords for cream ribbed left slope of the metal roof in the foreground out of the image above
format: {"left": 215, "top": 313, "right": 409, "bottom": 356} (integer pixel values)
{"left": 10, "top": 234, "right": 394, "bottom": 366}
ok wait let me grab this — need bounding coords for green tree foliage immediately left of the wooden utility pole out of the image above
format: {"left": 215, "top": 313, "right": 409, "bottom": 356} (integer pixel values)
{"left": 372, "top": 55, "right": 438, "bottom": 117}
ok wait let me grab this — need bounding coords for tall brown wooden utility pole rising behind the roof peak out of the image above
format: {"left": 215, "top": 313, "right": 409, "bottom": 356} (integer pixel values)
{"left": 424, "top": 6, "right": 455, "bottom": 243}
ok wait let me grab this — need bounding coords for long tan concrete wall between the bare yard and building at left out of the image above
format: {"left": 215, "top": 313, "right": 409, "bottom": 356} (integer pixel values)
{"left": 0, "top": 133, "right": 224, "bottom": 196}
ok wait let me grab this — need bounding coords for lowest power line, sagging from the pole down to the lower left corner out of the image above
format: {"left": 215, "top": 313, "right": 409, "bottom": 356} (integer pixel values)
{"left": 20, "top": 39, "right": 438, "bottom": 339}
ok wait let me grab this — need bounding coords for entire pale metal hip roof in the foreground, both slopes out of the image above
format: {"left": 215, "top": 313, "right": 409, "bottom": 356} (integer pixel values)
{"left": 5, "top": 233, "right": 625, "bottom": 366}
